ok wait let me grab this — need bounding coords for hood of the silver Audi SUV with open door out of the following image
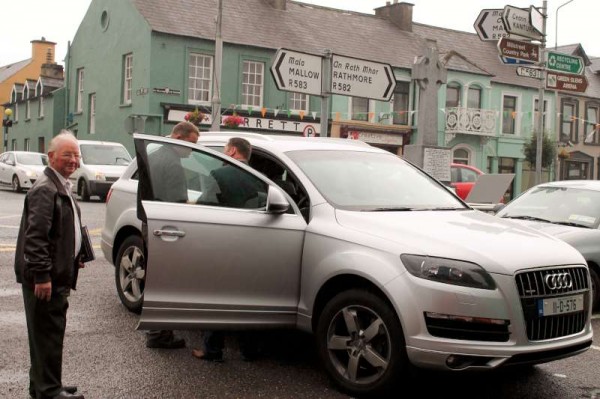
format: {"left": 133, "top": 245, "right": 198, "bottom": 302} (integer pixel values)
{"left": 336, "top": 210, "right": 584, "bottom": 274}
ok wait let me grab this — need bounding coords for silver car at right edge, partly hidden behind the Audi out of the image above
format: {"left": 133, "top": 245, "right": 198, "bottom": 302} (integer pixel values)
{"left": 497, "top": 180, "right": 600, "bottom": 309}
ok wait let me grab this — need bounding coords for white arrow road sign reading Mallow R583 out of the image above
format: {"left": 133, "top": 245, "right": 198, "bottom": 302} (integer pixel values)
{"left": 271, "top": 49, "right": 323, "bottom": 96}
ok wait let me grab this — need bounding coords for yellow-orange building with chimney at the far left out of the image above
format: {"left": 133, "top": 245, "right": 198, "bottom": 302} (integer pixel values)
{"left": 0, "top": 37, "right": 56, "bottom": 115}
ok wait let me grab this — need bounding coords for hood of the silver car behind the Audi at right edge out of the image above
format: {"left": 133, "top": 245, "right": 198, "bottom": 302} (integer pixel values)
{"left": 496, "top": 219, "right": 600, "bottom": 263}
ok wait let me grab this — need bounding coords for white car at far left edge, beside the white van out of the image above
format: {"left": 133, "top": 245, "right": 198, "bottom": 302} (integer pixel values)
{"left": 0, "top": 151, "right": 48, "bottom": 192}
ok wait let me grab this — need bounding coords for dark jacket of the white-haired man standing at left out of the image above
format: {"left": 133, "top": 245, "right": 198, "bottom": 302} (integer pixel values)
{"left": 15, "top": 168, "right": 81, "bottom": 291}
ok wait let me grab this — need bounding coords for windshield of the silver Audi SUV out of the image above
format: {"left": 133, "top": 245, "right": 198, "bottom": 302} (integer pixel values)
{"left": 287, "top": 151, "right": 468, "bottom": 211}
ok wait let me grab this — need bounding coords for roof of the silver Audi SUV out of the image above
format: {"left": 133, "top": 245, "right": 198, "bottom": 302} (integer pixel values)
{"left": 198, "top": 131, "right": 390, "bottom": 154}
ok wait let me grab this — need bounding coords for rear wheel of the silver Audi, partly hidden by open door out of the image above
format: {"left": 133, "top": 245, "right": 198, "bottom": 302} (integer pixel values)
{"left": 115, "top": 235, "right": 146, "bottom": 314}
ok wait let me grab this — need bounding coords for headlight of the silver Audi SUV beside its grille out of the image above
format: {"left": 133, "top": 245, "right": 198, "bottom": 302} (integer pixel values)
{"left": 400, "top": 254, "right": 496, "bottom": 290}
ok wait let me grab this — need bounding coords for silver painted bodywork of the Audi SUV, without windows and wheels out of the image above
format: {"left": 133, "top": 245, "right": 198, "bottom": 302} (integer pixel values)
{"left": 102, "top": 133, "right": 592, "bottom": 396}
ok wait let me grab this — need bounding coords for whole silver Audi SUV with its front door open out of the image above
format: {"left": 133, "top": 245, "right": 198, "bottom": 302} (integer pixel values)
{"left": 102, "top": 133, "right": 592, "bottom": 395}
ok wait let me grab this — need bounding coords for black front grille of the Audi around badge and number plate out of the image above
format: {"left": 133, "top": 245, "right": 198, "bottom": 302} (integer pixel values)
{"left": 515, "top": 267, "right": 590, "bottom": 341}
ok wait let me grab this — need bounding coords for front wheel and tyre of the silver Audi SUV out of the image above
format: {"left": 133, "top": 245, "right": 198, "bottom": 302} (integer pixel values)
{"left": 316, "top": 289, "right": 410, "bottom": 397}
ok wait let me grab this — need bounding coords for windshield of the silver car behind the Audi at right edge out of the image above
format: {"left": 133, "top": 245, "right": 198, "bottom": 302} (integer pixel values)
{"left": 498, "top": 187, "right": 600, "bottom": 228}
